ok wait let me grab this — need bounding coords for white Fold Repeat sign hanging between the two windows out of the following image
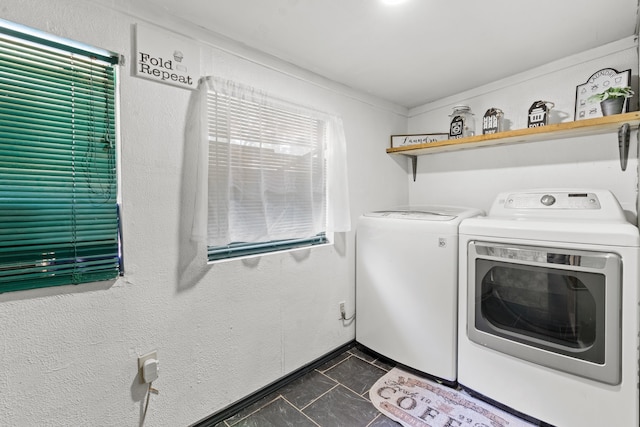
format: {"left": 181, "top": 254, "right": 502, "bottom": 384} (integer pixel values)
{"left": 134, "top": 24, "right": 200, "bottom": 89}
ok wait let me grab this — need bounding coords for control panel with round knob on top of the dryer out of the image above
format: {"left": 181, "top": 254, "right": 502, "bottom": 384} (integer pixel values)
{"left": 504, "top": 192, "right": 600, "bottom": 210}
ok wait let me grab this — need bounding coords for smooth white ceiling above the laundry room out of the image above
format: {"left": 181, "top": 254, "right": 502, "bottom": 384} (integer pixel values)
{"left": 135, "top": 0, "right": 638, "bottom": 108}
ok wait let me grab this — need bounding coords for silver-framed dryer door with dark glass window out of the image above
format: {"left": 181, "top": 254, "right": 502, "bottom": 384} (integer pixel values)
{"left": 468, "top": 242, "right": 621, "bottom": 383}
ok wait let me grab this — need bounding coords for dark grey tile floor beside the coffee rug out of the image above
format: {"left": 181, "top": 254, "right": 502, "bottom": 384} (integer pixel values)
{"left": 216, "top": 347, "right": 400, "bottom": 427}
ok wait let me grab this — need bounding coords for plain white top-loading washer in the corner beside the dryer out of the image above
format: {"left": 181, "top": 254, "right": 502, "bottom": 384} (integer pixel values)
{"left": 356, "top": 206, "right": 482, "bottom": 382}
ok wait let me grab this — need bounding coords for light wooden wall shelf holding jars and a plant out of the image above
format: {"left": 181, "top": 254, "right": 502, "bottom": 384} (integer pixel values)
{"left": 387, "top": 111, "right": 640, "bottom": 157}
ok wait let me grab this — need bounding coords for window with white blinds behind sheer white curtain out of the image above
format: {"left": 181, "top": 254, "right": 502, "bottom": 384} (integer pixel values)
{"left": 206, "top": 78, "right": 348, "bottom": 260}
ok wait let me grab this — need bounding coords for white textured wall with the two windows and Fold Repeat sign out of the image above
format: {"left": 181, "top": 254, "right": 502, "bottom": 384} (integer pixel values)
{"left": 0, "top": 0, "right": 408, "bottom": 427}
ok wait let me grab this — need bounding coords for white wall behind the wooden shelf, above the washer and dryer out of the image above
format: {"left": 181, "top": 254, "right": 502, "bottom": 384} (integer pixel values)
{"left": 408, "top": 38, "right": 638, "bottom": 222}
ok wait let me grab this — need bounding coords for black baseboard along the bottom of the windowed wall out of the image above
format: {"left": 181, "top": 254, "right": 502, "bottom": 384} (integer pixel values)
{"left": 191, "top": 340, "right": 356, "bottom": 427}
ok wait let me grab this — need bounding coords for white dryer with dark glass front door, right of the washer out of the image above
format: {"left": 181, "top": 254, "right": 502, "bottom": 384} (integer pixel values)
{"left": 458, "top": 189, "right": 640, "bottom": 427}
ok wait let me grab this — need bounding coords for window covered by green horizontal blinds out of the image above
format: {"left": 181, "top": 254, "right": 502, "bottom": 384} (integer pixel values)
{"left": 0, "top": 21, "right": 120, "bottom": 292}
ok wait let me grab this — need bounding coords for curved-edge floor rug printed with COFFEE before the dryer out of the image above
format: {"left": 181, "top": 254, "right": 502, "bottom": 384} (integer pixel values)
{"left": 369, "top": 368, "right": 533, "bottom": 427}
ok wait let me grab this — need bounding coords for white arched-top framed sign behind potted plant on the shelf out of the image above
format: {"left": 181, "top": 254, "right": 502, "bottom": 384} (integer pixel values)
{"left": 574, "top": 68, "right": 631, "bottom": 120}
